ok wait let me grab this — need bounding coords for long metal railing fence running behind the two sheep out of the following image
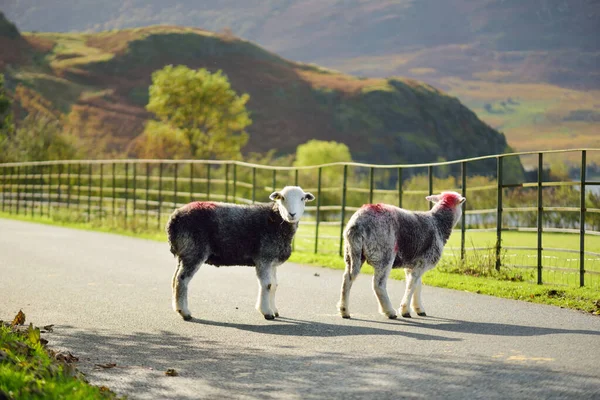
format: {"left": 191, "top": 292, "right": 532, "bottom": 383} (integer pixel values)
{"left": 0, "top": 149, "right": 600, "bottom": 286}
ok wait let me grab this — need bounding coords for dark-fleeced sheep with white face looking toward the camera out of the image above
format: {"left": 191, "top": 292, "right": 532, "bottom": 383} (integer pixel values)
{"left": 167, "top": 186, "right": 315, "bottom": 320}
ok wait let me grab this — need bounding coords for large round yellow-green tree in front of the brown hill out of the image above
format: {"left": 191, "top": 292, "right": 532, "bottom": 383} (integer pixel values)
{"left": 146, "top": 65, "right": 252, "bottom": 159}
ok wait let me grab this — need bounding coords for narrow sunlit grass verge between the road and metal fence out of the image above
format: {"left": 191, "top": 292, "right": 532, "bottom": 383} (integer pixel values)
{"left": 0, "top": 212, "right": 600, "bottom": 315}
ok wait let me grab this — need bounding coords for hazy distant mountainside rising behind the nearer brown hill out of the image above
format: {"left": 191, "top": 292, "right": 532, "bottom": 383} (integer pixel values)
{"left": 2, "top": 0, "right": 600, "bottom": 164}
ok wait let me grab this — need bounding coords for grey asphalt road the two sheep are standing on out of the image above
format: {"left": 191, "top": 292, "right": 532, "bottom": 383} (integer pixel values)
{"left": 0, "top": 219, "right": 600, "bottom": 399}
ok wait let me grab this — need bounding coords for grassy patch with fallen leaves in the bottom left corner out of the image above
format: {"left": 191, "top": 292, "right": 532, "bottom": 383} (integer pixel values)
{"left": 0, "top": 313, "right": 118, "bottom": 400}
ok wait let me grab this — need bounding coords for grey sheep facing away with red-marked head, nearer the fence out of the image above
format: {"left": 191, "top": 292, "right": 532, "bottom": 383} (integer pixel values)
{"left": 338, "top": 192, "right": 466, "bottom": 318}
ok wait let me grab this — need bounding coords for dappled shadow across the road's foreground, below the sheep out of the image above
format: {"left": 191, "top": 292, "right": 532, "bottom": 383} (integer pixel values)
{"left": 47, "top": 321, "right": 600, "bottom": 399}
